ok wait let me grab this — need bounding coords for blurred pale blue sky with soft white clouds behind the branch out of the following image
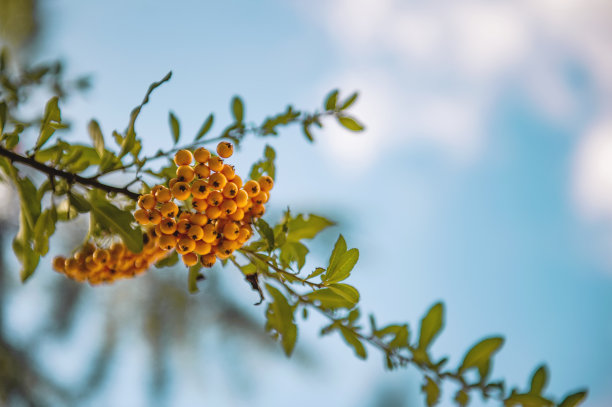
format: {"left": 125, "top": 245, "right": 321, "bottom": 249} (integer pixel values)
{"left": 4, "top": 0, "right": 612, "bottom": 406}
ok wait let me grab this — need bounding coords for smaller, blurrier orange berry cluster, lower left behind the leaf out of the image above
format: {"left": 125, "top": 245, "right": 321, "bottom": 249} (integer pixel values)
{"left": 53, "top": 230, "right": 168, "bottom": 285}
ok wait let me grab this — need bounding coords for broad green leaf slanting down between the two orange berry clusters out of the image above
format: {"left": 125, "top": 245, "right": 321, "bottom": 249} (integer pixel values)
{"left": 90, "top": 198, "right": 142, "bottom": 253}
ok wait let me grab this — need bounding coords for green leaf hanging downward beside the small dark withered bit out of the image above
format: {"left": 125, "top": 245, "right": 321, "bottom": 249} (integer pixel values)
{"left": 266, "top": 284, "right": 297, "bottom": 356}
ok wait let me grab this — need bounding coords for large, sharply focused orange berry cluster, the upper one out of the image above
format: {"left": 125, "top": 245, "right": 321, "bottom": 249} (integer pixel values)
{"left": 134, "top": 142, "right": 274, "bottom": 267}
